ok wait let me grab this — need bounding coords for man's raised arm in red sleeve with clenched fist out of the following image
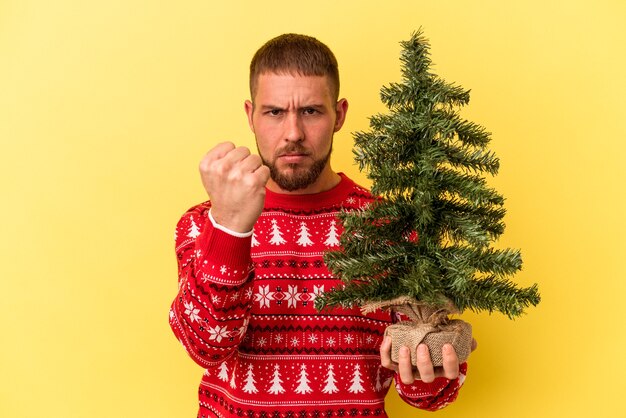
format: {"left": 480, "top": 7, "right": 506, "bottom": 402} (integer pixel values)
{"left": 170, "top": 143, "right": 269, "bottom": 367}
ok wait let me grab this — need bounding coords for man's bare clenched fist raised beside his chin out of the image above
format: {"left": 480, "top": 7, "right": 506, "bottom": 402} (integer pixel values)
{"left": 200, "top": 142, "right": 270, "bottom": 232}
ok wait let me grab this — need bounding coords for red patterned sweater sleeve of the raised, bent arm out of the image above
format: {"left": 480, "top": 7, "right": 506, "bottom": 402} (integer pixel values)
{"left": 169, "top": 203, "right": 254, "bottom": 368}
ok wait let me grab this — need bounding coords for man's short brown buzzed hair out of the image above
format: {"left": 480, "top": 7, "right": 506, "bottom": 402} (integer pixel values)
{"left": 250, "top": 33, "right": 339, "bottom": 101}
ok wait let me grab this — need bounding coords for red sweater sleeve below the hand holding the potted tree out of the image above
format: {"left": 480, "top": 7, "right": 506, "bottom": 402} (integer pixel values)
{"left": 395, "top": 363, "right": 467, "bottom": 411}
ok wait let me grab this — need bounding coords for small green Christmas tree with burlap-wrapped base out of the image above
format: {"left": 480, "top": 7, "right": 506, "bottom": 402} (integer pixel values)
{"left": 316, "top": 30, "right": 540, "bottom": 366}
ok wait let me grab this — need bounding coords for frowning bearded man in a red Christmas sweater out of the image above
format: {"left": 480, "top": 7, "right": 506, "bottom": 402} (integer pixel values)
{"left": 170, "top": 34, "right": 466, "bottom": 417}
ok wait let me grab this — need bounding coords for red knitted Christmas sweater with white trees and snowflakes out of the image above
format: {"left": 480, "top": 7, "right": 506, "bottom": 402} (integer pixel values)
{"left": 170, "top": 174, "right": 466, "bottom": 418}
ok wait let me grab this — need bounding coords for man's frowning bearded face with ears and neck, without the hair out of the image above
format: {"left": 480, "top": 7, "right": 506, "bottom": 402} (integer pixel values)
{"left": 245, "top": 73, "right": 348, "bottom": 193}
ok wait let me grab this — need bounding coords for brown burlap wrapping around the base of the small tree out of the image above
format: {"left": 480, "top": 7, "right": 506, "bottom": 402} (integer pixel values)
{"left": 362, "top": 297, "right": 472, "bottom": 367}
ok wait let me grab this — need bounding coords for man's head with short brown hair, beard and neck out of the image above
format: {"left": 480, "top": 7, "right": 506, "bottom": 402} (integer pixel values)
{"left": 245, "top": 34, "right": 348, "bottom": 193}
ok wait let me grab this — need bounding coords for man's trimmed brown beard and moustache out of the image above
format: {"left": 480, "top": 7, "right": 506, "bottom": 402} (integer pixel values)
{"left": 257, "top": 143, "right": 333, "bottom": 192}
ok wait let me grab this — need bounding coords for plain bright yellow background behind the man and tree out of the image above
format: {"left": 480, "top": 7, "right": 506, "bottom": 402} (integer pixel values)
{"left": 0, "top": 0, "right": 626, "bottom": 418}
